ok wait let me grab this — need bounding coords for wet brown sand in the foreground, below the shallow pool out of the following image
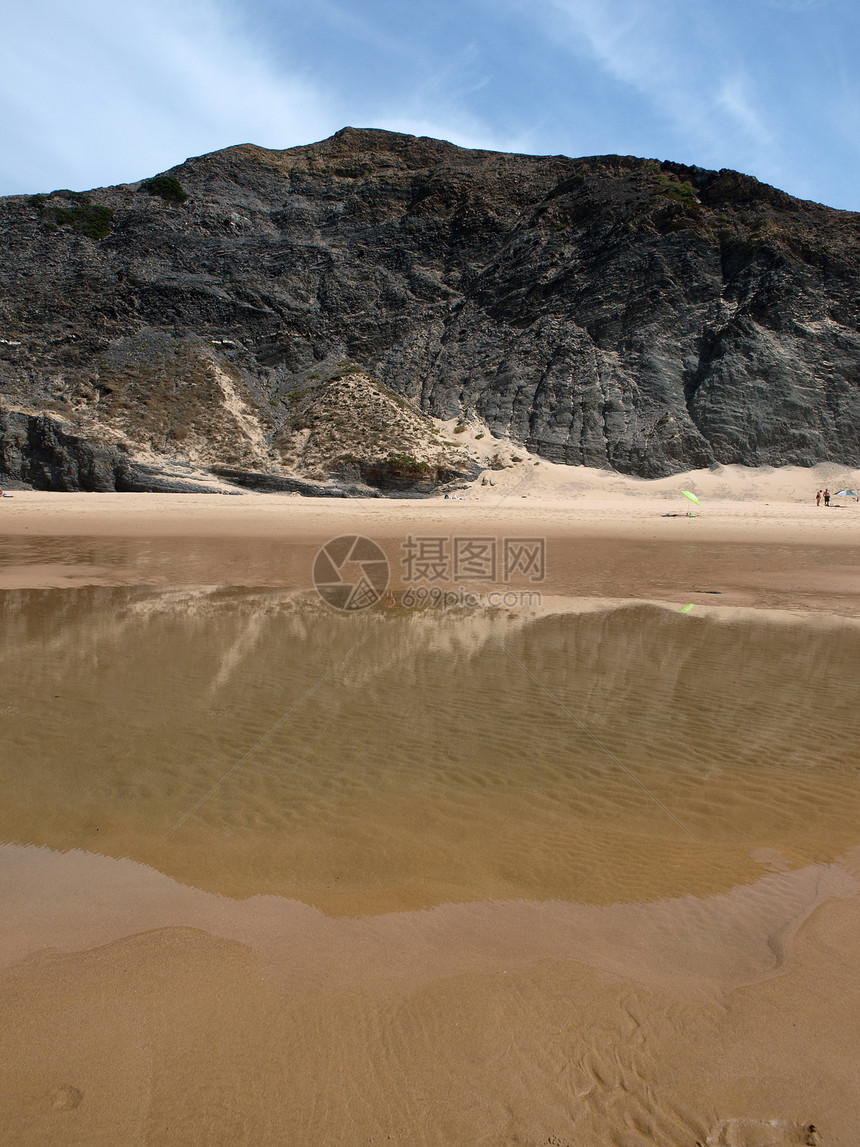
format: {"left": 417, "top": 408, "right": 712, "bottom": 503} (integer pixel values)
{"left": 0, "top": 850, "right": 860, "bottom": 1147}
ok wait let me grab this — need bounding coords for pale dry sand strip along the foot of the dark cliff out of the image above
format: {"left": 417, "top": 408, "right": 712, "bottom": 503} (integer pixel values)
{"left": 0, "top": 459, "right": 860, "bottom": 546}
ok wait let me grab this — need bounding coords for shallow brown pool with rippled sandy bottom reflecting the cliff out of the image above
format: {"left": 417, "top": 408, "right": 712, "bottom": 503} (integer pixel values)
{"left": 0, "top": 587, "right": 860, "bottom": 915}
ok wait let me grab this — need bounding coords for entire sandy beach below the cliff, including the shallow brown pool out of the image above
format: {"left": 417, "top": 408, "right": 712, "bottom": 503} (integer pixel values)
{"left": 0, "top": 460, "right": 860, "bottom": 1147}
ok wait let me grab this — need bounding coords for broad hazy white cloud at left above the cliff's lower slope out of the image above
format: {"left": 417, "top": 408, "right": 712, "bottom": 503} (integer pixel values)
{"left": 0, "top": 0, "right": 339, "bottom": 194}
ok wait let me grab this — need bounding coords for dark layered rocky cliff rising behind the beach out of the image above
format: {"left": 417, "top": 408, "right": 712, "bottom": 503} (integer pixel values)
{"left": 0, "top": 128, "right": 860, "bottom": 483}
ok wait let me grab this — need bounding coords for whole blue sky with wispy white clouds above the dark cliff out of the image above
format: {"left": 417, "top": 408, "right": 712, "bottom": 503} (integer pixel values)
{"left": 0, "top": 0, "right": 860, "bottom": 210}
